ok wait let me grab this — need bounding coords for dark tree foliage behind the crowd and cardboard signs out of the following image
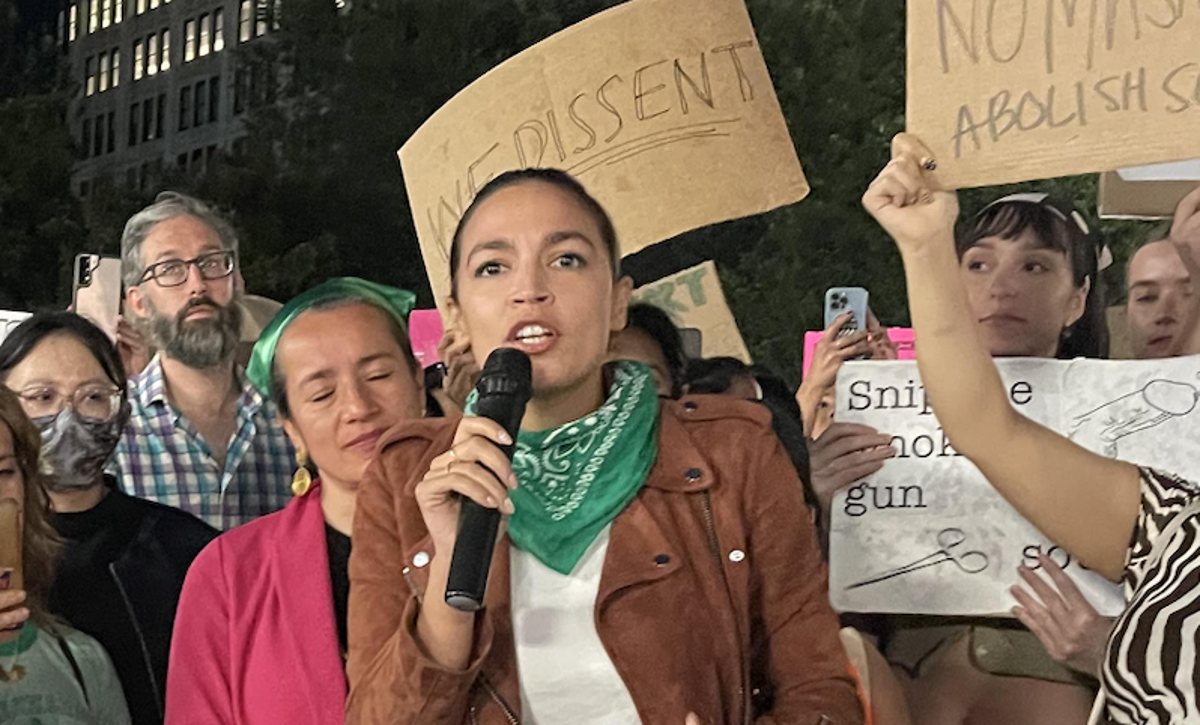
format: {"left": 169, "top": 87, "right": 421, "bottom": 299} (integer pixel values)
{"left": 0, "top": 0, "right": 1142, "bottom": 382}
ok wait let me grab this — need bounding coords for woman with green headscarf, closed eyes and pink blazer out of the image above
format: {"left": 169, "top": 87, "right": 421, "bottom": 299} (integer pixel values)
{"left": 167, "top": 277, "right": 425, "bottom": 725}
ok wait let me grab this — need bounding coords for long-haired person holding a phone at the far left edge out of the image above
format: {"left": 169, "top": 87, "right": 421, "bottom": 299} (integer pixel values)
{"left": 0, "top": 385, "right": 130, "bottom": 725}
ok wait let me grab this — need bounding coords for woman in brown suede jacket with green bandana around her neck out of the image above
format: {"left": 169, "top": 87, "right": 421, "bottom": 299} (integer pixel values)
{"left": 347, "top": 169, "right": 863, "bottom": 725}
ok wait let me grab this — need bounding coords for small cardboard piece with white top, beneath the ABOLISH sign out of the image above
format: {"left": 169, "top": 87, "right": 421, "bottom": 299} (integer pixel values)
{"left": 1097, "top": 158, "right": 1200, "bottom": 220}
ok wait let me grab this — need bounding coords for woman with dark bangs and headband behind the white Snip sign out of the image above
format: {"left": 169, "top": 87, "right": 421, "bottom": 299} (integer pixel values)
{"left": 809, "top": 189, "right": 1110, "bottom": 724}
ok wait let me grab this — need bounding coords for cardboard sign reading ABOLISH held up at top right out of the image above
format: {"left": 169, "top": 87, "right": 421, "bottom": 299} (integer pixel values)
{"left": 907, "top": 0, "right": 1200, "bottom": 188}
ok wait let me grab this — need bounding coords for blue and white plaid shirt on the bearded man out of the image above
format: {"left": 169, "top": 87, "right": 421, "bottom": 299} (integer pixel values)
{"left": 110, "top": 356, "right": 295, "bottom": 529}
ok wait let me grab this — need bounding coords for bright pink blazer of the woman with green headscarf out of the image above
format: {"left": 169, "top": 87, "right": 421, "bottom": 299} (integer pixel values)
{"left": 167, "top": 485, "right": 347, "bottom": 725}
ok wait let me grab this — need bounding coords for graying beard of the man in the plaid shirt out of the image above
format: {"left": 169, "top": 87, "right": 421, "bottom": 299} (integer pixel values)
{"left": 146, "top": 295, "right": 241, "bottom": 370}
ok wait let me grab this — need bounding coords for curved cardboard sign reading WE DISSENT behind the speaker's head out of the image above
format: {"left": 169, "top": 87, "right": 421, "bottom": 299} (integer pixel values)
{"left": 400, "top": 0, "right": 809, "bottom": 304}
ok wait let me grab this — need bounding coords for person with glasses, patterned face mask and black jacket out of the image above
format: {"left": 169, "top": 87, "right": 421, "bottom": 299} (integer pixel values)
{"left": 0, "top": 312, "right": 217, "bottom": 725}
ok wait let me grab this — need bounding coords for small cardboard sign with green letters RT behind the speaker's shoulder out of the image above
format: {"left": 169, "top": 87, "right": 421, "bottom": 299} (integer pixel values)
{"left": 634, "top": 262, "right": 751, "bottom": 363}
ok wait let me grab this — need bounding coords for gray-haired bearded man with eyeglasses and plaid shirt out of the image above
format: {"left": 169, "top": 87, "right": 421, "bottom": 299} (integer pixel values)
{"left": 113, "top": 192, "right": 294, "bottom": 529}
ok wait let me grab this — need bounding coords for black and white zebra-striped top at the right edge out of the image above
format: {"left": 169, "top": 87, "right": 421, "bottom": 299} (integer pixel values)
{"left": 1102, "top": 468, "right": 1200, "bottom": 725}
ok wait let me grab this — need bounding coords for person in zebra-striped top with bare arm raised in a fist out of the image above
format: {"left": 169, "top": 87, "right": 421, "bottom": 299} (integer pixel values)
{"left": 863, "top": 137, "right": 1200, "bottom": 725}
